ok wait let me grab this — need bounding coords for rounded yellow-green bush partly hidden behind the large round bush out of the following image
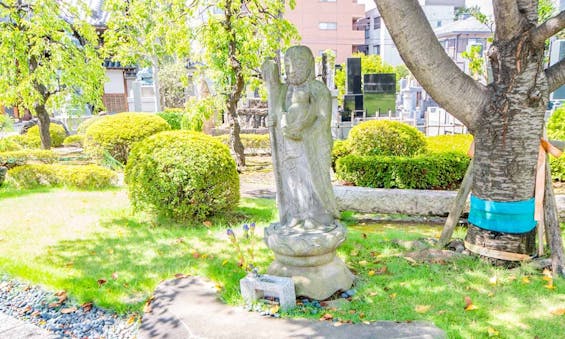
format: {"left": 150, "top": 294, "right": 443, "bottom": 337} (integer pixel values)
{"left": 84, "top": 113, "right": 170, "bottom": 164}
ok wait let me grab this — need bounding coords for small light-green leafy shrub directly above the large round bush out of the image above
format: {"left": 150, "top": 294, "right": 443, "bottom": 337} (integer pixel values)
{"left": 181, "top": 96, "right": 224, "bottom": 132}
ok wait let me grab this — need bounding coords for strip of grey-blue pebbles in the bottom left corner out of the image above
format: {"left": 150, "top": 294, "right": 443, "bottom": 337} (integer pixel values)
{"left": 0, "top": 276, "right": 139, "bottom": 338}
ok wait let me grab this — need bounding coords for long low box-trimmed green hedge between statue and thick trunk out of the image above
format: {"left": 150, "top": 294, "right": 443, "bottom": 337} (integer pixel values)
{"left": 336, "top": 152, "right": 470, "bottom": 189}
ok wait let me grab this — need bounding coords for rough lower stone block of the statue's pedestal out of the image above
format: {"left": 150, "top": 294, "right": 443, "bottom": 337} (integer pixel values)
{"left": 268, "top": 254, "right": 353, "bottom": 300}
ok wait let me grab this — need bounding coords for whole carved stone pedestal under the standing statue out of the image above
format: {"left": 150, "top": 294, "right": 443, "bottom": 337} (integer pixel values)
{"left": 265, "top": 221, "right": 353, "bottom": 300}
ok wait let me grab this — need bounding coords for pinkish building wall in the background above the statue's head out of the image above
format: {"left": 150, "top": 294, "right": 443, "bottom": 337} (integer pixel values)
{"left": 285, "top": 0, "right": 365, "bottom": 63}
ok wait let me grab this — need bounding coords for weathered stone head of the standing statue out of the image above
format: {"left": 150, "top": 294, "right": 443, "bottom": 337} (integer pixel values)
{"left": 284, "top": 46, "right": 315, "bottom": 85}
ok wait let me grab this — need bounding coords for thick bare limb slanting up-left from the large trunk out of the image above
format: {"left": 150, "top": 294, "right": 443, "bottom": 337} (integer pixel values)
{"left": 375, "top": 0, "right": 488, "bottom": 129}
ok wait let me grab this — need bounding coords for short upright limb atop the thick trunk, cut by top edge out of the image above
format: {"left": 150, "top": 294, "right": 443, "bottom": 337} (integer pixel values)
{"left": 492, "top": 0, "right": 522, "bottom": 41}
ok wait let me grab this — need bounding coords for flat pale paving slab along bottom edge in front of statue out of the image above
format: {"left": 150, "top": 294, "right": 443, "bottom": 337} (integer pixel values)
{"left": 139, "top": 277, "right": 446, "bottom": 339}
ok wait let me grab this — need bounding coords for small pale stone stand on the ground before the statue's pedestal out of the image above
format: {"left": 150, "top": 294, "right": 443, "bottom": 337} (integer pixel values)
{"left": 239, "top": 274, "right": 296, "bottom": 311}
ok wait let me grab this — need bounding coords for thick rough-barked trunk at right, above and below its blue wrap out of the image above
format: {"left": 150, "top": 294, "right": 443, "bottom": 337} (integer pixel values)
{"left": 467, "top": 36, "right": 549, "bottom": 255}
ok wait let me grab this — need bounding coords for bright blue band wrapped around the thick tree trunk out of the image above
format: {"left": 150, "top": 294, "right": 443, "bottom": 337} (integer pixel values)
{"left": 469, "top": 195, "right": 537, "bottom": 234}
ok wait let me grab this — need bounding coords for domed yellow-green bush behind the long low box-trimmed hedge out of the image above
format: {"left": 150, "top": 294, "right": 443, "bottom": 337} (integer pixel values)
{"left": 348, "top": 120, "right": 426, "bottom": 156}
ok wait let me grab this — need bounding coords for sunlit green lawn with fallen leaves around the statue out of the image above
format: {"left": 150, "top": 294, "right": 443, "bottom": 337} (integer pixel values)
{"left": 0, "top": 189, "right": 565, "bottom": 338}
